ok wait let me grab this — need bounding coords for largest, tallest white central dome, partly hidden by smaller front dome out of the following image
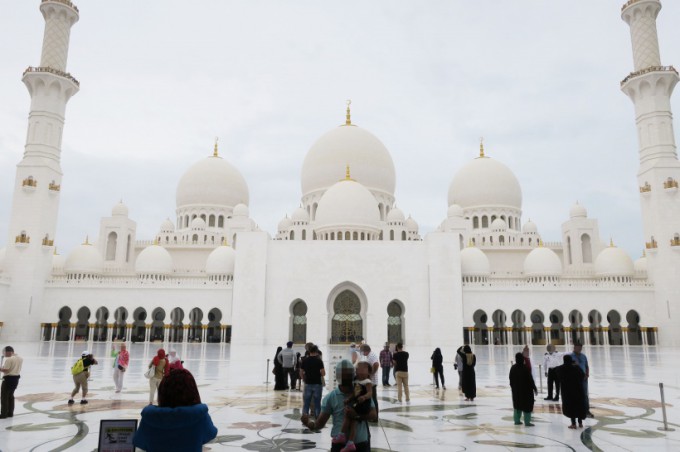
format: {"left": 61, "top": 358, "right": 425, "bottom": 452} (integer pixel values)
{"left": 302, "top": 125, "right": 395, "bottom": 196}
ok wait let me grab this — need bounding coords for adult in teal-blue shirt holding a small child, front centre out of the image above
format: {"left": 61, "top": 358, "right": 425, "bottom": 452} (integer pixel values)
{"left": 301, "top": 359, "right": 378, "bottom": 452}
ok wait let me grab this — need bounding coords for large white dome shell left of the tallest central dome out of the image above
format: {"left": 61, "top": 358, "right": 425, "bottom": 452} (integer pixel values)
{"left": 176, "top": 156, "right": 249, "bottom": 209}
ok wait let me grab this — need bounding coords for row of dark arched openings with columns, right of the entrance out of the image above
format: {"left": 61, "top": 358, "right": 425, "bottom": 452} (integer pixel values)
{"left": 464, "top": 309, "right": 657, "bottom": 345}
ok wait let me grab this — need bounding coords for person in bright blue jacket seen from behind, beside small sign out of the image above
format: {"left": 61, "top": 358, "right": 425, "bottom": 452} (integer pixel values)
{"left": 132, "top": 369, "right": 217, "bottom": 452}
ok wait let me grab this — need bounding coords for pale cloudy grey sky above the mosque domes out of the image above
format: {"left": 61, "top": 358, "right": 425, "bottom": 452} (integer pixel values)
{"left": 0, "top": 0, "right": 680, "bottom": 259}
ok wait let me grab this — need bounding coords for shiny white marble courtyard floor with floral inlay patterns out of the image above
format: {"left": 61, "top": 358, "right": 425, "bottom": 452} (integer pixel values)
{"left": 0, "top": 342, "right": 680, "bottom": 452}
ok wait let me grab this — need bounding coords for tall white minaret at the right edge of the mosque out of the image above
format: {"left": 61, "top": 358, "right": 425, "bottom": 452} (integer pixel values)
{"left": 621, "top": 0, "right": 680, "bottom": 345}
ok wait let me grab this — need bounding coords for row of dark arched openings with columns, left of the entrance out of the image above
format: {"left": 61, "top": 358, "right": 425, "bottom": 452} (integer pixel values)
{"left": 45, "top": 306, "right": 231, "bottom": 343}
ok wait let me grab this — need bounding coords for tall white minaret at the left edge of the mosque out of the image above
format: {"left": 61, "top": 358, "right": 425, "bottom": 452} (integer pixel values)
{"left": 0, "top": 0, "right": 79, "bottom": 341}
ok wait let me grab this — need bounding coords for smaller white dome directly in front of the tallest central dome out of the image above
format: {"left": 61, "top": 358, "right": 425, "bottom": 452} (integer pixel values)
{"left": 316, "top": 179, "right": 380, "bottom": 228}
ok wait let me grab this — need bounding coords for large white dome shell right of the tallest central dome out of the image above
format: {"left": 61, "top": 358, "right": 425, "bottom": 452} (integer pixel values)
{"left": 449, "top": 151, "right": 522, "bottom": 209}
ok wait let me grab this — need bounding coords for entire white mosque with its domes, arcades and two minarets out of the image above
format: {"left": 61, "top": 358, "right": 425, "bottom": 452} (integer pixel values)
{"left": 0, "top": 0, "right": 680, "bottom": 346}
